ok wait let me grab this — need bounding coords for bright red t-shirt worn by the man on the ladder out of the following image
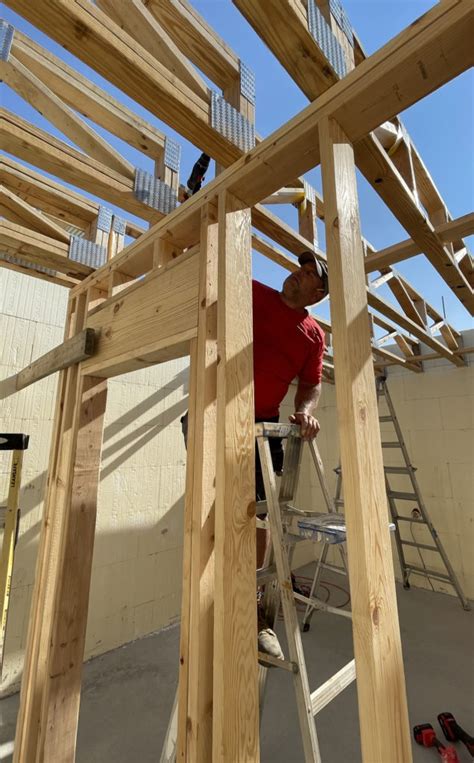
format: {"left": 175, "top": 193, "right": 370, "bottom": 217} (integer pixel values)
{"left": 252, "top": 281, "right": 325, "bottom": 418}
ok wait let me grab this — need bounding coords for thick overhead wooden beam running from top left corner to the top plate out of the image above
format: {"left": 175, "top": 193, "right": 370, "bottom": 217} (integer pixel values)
{"left": 3, "top": 0, "right": 240, "bottom": 165}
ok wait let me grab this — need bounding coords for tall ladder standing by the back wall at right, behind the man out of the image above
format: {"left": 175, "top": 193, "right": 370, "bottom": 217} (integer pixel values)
{"left": 326, "top": 376, "right": 471, "bottom": 611}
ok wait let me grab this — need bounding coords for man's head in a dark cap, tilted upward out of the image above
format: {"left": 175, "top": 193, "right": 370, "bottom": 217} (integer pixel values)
{"left": 282, "top": 251, "right": 329, "bottom": 308}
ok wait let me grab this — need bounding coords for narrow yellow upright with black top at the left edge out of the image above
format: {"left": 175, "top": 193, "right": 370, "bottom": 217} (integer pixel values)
{"left": 0, "top": 433, "right": 29, "bottom": 677}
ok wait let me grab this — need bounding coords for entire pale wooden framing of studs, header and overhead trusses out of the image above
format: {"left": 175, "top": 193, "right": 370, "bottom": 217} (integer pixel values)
{"left": 0, "top": 0, "right": 474, "bottom": 763}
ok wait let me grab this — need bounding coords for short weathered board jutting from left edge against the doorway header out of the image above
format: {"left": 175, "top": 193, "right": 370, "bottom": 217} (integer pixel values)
{"left": 11, "top": 328, "right": 96, "bottom": 390}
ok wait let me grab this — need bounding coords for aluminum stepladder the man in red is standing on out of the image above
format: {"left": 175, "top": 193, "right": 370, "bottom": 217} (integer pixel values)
{"left": 255, "top": 423, "right": 355, "bottom": 763}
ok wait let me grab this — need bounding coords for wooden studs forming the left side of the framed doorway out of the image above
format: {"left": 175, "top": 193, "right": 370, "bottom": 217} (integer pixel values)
{"left": 14, "top": 295, "right": 106, "bottom": 763}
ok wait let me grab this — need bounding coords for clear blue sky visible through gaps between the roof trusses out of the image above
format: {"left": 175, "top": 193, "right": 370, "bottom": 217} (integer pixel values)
{"left": 2, "top": 0, "right": 474, "bottom": 329}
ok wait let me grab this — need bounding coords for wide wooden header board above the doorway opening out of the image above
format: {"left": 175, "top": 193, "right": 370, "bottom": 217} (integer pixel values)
{"left": 81, "top": 253, "right": 199, "bottom": 376}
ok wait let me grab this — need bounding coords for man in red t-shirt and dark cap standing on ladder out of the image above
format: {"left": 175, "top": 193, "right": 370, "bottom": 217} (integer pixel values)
{"left": 181, "top": 251, "right": 329, "bottom": 659}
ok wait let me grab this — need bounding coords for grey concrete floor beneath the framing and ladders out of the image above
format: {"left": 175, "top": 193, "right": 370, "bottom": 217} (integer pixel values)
{"left": 0, "top": 588, "right": 474, "bottom": 763}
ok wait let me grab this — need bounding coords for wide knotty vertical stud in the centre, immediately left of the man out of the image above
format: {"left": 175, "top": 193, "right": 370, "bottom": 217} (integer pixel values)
{"left": 212, "top": 191, "right": 259, "bottom": 763}
